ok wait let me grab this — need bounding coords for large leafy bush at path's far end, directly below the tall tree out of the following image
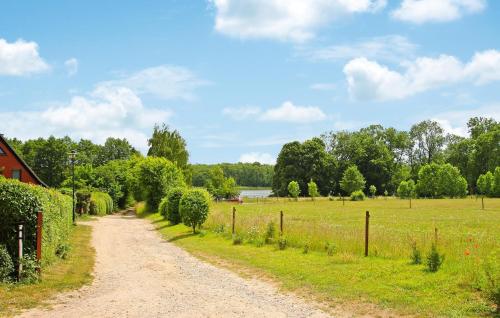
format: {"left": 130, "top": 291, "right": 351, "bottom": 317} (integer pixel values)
{"left": 136, "top": 157, "right": 185, "bottom": 211}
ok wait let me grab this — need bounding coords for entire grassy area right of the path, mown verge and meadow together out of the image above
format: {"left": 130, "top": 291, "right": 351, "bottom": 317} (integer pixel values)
{"left": 140, "top": 198, "right": 500, "bottom": 317}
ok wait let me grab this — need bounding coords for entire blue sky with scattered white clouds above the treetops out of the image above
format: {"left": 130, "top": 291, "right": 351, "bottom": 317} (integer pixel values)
{"left": 0, "top": 0, "right": 500, "bottom": 163}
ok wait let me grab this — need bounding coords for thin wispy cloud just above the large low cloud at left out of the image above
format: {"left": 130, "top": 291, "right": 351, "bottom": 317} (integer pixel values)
{"left": 100, "top": 65, "right": 208, "bottom": 100}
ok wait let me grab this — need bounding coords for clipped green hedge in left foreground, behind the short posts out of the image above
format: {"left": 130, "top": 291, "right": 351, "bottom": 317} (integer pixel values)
{"left": 0, "top": 178, "right": 72, "bottom": 265}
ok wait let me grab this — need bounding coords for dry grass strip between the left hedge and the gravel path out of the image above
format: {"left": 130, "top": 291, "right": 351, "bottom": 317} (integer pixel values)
{"left": 0, "top": 225, "right": 95, "bottom": 316}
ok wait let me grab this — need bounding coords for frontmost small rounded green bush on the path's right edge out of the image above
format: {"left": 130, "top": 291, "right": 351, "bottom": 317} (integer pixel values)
{"left": 179, "top": 189, "right": 210, "bottom": 233}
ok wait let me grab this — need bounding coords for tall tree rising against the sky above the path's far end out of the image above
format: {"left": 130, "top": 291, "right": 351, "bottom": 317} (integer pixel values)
{"left": 148, "top": 124, "right": 189, "bottom": 170}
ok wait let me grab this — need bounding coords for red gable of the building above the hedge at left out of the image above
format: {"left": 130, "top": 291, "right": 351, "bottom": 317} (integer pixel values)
{"left": 0, "top": 134, "right": 46, "bottom": 187}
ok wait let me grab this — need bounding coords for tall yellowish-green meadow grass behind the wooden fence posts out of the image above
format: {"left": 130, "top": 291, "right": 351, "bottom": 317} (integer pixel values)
{"left": 204, "top": 198, "right": 500, "bottom": 264}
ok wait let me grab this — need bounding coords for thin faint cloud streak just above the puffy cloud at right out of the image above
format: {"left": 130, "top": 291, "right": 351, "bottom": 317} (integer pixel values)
{"left": 298, "top": 35, "right": 417, "bottom": 61}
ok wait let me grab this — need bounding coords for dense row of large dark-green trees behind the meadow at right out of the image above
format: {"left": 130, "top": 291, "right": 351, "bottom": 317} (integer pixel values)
{"left": 272, "top": 117, "right": 500, "bottom": 197}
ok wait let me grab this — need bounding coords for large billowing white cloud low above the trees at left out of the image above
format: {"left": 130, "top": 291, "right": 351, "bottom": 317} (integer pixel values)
{"left": 0, "top": 86, "right": 171, "bottom": 151}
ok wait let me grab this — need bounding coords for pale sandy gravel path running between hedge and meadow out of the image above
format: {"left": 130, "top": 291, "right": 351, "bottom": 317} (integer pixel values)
{"left": 18, "top": 215, "right": 329, "bottom": 317}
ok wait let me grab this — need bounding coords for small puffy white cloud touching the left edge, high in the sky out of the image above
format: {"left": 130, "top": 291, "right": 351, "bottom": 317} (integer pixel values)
{"left": 0, "top": 39, "right": 50, "bottom": 76}
